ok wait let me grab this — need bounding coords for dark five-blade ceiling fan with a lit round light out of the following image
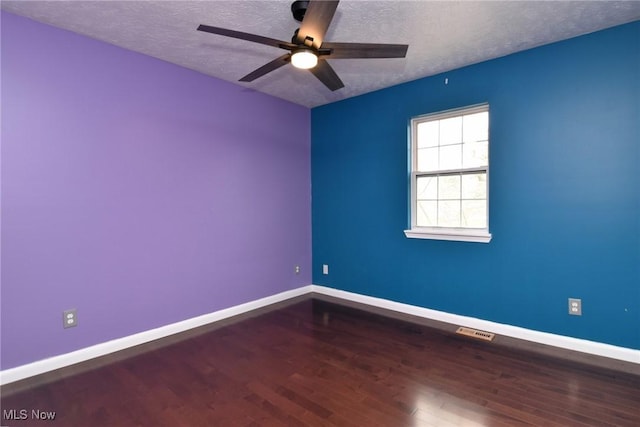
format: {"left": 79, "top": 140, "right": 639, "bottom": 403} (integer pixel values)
{"left": 198, "top": 0, "right": 409, "bottom": 91}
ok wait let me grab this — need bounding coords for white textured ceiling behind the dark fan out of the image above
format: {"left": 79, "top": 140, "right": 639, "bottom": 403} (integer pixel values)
{"left": 2, "top": 0, "right": 640, "bottom": 107}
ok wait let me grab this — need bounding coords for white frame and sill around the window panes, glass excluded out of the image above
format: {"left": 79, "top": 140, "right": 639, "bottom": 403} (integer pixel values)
{"left": 404, "top": 104, "right": 492, "bottom": 243}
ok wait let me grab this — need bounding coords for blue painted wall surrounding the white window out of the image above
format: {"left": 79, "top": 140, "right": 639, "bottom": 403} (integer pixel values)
{"left": 311, "top": 22, "right": 640, "bottom": 349}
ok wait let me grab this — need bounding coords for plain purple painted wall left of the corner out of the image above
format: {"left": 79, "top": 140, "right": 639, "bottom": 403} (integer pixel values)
{"left": 1, "top": 12, "right": 311, "bottom": 369}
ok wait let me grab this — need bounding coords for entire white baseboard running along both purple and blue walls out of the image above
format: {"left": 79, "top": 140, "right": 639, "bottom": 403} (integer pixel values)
{"left": 0, "top": 285, "right": 640, "bottom": 385}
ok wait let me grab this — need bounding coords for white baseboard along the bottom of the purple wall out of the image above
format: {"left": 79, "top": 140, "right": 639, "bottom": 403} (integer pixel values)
{"left": 0, "top": 285, "right": 311, "bottom": 385}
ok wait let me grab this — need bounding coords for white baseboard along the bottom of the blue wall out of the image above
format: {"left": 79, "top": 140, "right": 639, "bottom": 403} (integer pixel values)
{"left": 311, "top": 285, "right": 640, "bottom": 364}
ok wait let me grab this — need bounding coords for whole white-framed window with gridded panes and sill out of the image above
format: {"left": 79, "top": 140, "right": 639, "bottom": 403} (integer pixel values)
{"left": 405, "top": 104, "right": 491, "bottom": 243}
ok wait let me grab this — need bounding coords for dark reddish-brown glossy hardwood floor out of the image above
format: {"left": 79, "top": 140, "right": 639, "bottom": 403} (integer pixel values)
{"left": 2, "top": 299, "right": 640, "bottom": 427}
